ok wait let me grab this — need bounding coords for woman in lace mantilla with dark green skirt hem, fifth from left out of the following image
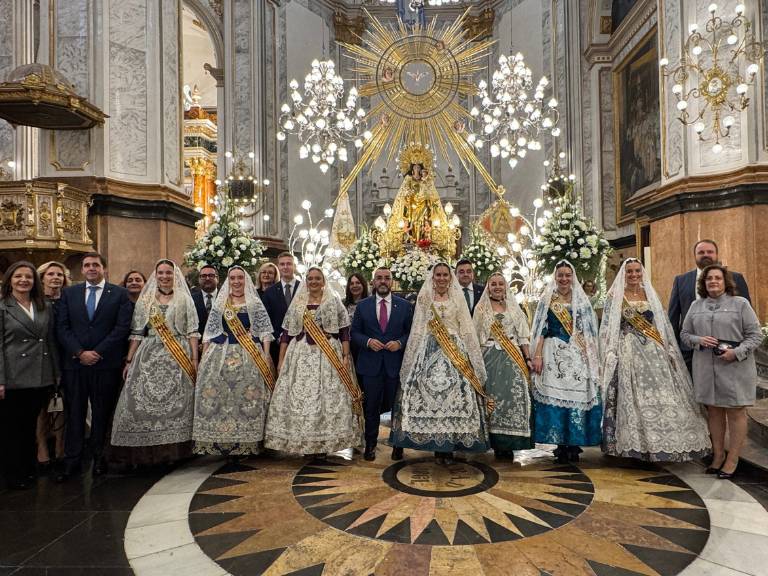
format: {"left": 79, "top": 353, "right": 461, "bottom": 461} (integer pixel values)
{"left": 473, "top": 272, "right": 533, "bottom": 460}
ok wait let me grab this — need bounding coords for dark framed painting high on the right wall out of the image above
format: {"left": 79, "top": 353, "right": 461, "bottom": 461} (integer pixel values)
{"left": 613, "top": 29, "right": 661, "bottom": 225}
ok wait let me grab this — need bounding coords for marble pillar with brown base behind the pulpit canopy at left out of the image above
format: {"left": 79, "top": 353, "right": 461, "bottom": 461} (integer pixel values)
{"left": 39, "top": 0, "right": 197, "bottom": 272}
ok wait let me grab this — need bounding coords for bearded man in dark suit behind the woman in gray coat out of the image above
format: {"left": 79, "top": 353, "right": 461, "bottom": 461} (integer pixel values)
{"left": 667, "top": 240, "right": 749, "bottom": 372}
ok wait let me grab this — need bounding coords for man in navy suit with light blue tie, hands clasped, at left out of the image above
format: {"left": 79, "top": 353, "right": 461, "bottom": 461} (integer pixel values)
{"left": 56, "top": 252, "right": 133, "bottom": 482}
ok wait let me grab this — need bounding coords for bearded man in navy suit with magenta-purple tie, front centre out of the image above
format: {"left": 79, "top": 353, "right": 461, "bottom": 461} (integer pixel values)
{"left": 352, "top": 267, "right": 413, "bottom": 461}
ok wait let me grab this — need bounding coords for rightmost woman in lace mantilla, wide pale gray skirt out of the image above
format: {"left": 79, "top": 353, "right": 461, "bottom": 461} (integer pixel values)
{"left": 600, "top": 258, "right": 710, "bottom": 462}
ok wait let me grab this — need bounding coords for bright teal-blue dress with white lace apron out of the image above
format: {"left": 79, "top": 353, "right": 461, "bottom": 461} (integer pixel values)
{"left": 533, "top": 310, "right": 603, "bottom": 446}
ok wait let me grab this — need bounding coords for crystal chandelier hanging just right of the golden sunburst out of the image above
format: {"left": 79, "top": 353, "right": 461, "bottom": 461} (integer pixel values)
{"left": 467, "top": 52, "right": 560, "bottom": 168}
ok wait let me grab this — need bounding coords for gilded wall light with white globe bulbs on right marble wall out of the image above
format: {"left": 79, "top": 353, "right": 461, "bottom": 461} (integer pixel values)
{"left": 659, "top": 4, "right": 765, "bottom": 154}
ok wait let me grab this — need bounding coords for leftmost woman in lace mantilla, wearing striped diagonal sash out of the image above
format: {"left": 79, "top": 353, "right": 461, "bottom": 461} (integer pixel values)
{"left": 112, "top": 260, "right": 200, "bottom": 464}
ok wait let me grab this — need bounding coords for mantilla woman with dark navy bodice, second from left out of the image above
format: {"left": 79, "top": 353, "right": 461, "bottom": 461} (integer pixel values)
{"left": 193, "top": 266, "right": 274, "bottom": 456}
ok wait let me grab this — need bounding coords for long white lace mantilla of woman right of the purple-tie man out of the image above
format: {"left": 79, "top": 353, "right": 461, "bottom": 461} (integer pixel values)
{"left": 400, "top": 266, "right": 486, "bottom": 382}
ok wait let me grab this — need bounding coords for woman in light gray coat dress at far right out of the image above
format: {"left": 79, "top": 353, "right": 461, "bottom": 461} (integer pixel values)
{"left": 680, "top": 264, "right": 762, "bottom": 479}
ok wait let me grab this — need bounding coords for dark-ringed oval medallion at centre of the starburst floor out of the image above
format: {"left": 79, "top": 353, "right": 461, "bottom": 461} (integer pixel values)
{"left": 382, "top": 458, "right": 499, "bottom": 498}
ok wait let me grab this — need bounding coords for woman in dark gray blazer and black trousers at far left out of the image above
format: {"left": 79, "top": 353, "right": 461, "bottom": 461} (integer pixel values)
{"left": 0, "top": 261, "right": 59, "bottom": 488}
